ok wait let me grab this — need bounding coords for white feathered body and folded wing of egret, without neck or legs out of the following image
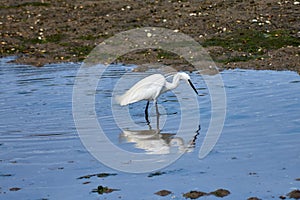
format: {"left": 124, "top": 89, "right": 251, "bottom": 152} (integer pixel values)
{"left": 117, "top": 74, "right": 165, "bottom": 106}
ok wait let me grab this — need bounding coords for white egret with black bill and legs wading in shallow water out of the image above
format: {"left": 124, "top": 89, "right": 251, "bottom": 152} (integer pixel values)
{"left": 116, "top": 72, "right": 198, "bottom": 124}
